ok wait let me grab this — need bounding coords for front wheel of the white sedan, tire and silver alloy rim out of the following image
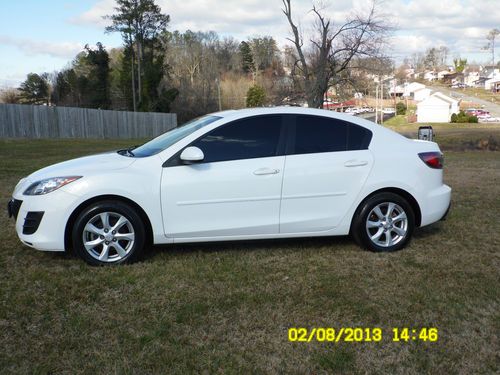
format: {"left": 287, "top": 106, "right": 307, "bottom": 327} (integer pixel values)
{"left": 72, "top": 200, "right": 146, "bottom": 266}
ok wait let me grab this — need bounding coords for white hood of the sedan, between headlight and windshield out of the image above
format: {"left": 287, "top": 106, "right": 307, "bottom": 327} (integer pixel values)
{"left": 27, "top": 152, "right": 136, "bottom": 182}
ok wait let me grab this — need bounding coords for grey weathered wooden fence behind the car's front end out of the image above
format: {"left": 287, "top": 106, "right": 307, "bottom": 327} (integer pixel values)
{"left": 0, "top": 104, "right": 177, "bottom": 138}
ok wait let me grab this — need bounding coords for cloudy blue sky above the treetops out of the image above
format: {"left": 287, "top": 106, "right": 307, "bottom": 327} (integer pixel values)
{"left": 0, "top": 0, "right": 500, "bottom": 87}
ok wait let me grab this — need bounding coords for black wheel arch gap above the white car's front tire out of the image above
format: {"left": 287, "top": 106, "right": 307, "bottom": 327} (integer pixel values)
{"left": 64, "top": 194, "right": 153, "bottom": 251}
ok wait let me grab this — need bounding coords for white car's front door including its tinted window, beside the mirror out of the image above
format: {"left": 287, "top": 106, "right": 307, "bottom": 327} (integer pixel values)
{"left": 161, "top": 115, "right": 285, "bottom": 240}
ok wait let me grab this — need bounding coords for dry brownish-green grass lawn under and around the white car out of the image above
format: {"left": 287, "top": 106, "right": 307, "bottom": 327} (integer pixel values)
{"left": 0, "top": 128, "right": 500, "bottom": 374}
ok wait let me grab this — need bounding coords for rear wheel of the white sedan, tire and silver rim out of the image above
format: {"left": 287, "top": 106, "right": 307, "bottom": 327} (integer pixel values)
{"left": 351, "top": 193, "right": 415, "bottom": 252}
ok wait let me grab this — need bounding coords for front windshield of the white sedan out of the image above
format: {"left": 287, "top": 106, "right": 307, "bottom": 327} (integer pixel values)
{"left": 133, "top": 116, "right": 222, "bottom": 157}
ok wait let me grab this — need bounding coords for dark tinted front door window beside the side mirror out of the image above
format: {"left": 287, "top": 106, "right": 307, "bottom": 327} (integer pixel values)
{"left": 192, "top": 115, "right": 281, "bottom": 163}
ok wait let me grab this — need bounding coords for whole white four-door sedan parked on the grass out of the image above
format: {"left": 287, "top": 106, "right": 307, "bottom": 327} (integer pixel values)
{"left": 8, "top": 107, "right": 451, "bottom": 265}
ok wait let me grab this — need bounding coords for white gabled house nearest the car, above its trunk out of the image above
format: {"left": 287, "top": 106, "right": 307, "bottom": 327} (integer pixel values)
{"left": 417, "top": 92, "right": 459, "bottom": 123}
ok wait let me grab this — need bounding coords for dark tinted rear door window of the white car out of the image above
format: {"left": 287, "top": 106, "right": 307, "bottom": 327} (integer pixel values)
{"left": 293, "top": 115, "right": 348, "bottom": 154}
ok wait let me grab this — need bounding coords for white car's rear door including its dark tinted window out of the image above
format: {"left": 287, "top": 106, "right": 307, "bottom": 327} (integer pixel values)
{"left": 280, "top": 115, "right": 373, "bottom": 233}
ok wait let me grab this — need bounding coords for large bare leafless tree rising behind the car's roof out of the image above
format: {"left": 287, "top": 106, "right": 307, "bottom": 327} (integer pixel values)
{"left": 282, "top": 0, "right": 390, "bottom": 108}
